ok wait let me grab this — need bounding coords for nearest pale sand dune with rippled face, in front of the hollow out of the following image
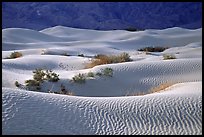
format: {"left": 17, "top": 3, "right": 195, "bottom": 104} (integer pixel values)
{"left": 2, "top": 82, "right": 202, "bottom": 135}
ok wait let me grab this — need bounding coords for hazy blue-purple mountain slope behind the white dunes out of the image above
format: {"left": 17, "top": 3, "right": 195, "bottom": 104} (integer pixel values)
{"left": 2, "top": 2, "right": 202, "bottom": 30}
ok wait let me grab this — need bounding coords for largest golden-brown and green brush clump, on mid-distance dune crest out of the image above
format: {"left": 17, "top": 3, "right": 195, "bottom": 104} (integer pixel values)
{"left": 86, "top": 52, "right": 131, "bottom": 68}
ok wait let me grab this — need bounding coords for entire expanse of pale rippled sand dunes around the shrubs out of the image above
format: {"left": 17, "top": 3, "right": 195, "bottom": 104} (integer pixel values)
{"left": 2, "top": 26, "right": 202, "bottom": 134}
